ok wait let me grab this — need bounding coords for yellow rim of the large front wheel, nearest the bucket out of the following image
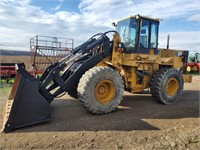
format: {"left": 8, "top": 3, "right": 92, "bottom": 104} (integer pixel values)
{"left": 95, "top": 80, "right": 115, "bottom": 104}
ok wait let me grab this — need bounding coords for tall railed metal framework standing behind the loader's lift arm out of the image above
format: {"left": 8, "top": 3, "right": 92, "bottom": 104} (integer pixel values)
{"left": 30, "top": 35, "right": 74, "bottom": 70}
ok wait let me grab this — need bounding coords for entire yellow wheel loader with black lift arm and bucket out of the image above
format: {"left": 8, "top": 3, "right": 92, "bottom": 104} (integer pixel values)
{"left": 2, "top": 15, "right": 192, "bottom": 132}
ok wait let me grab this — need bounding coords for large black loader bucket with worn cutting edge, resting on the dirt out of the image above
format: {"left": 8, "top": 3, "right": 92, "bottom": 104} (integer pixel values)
{"left": 2, "top": 65, "right": 51, "bottom": 132}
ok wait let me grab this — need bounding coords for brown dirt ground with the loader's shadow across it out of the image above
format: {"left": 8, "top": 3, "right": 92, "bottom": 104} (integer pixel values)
{"left": 0, "top": 76, "right": 200, "bottom": 150}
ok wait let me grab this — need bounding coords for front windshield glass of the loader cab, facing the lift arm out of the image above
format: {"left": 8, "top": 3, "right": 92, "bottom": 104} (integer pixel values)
{"left": 117, "top": 18, "right": 137, "bottom": 51}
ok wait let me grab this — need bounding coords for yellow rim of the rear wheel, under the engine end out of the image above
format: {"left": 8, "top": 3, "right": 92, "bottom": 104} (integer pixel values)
{"left": 166, "top": 78, "right": 179, "bottom": 96}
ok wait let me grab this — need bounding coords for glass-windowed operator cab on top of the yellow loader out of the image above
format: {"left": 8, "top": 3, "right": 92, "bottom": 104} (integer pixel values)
{"left": 116, "top": 15, "right": 159, "bottom": 54}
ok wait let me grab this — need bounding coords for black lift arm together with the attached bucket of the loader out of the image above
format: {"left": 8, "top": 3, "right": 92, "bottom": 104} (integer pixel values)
{"left": 2, "top": 31, "right": 118, "bottom": 132}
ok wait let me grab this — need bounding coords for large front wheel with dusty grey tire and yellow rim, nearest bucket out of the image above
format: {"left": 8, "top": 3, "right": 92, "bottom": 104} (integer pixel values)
{"left": 78, "top": 67, "right": 124, "bottom": 114}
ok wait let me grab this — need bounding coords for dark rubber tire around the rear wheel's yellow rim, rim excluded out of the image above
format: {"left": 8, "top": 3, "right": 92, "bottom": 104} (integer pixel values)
{"left": 150, "top": 68, "right": 184, "bottom": 105}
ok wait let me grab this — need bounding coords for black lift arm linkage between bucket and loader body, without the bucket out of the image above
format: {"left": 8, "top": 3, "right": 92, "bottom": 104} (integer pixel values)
{"left": 39, "top": 33, "right": 112, "bottom": 103}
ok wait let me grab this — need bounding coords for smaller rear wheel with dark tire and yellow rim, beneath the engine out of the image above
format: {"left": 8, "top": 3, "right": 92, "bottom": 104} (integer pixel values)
{"left": 150, "top": 68, "right": 184, "bottom": 105}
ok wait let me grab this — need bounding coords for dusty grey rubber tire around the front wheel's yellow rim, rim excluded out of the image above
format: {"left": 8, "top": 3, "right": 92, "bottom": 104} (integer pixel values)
{"left": 78, "top": 66, "right": 124, "bottom": 115}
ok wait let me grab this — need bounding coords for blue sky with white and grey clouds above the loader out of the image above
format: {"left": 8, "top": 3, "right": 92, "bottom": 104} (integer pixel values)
{"left": 0, "top": 0, "right": 200, "bottom": 52}
